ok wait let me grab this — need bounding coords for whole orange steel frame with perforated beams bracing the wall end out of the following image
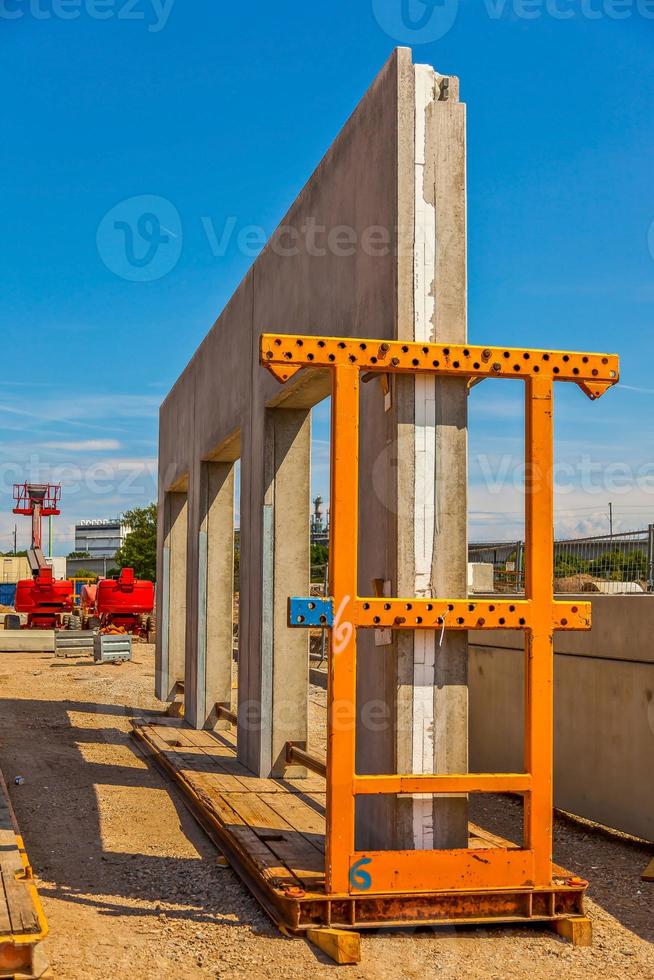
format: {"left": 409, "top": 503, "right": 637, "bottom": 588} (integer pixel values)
{"left": 261, "top": 334, "right": 619, "bottom": 897}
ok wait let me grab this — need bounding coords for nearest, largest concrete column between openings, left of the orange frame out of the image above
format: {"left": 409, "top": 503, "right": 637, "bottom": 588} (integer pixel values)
{"left": 238, "top": 408, "right": 311, "bottom": 776}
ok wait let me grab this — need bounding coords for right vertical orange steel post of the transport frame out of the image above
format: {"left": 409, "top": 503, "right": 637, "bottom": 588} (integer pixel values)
{"left": 525, "top": 376, "right": 554, "bottom": 885}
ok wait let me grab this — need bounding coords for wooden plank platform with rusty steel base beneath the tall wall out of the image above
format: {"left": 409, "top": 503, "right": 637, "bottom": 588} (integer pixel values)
{"left": 134, "top": 719, "right": 590, "bottom": 945}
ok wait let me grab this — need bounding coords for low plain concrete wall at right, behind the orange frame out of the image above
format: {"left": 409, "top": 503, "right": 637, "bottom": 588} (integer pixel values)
{"left": 470, "top": 593, "right": 654, "bottom": 841}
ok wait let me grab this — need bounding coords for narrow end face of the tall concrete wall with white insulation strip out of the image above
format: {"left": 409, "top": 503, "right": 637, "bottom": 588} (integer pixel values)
{"left": 397, "top": 65, "right": 468, "bottom": 849}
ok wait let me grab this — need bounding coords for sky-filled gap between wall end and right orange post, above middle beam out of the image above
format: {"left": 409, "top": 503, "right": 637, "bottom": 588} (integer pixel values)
{"left": 468, "top": 380, "right": 525, "bottom": 594}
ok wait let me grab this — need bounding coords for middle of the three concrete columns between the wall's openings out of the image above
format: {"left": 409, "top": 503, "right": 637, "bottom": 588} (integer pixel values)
{"left": 185, "top": 462, "right": 234, "bottom": 729}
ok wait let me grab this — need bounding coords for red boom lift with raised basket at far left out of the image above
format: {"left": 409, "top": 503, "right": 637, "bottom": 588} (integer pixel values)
{"left": 14, "top": 483, "right": 74, "bottom": 629}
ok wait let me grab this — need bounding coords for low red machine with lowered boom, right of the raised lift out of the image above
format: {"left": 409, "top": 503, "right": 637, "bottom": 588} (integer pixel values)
{"left": 81, "top": 568, "right": 154, "bottom": 638}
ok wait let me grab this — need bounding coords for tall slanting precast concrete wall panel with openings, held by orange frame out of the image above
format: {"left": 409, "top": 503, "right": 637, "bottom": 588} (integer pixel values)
{"left": 157, "top": 49, "right": 466, "bottom": 846}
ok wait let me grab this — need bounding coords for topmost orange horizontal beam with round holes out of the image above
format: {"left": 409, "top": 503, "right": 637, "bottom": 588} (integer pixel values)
{"left": 261, "top": 334, "right": 620, "bottom": 399}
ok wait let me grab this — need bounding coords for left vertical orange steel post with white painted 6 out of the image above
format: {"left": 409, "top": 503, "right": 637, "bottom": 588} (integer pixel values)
{"left": 326, "top": 366, "right": 359, "bottom": 893}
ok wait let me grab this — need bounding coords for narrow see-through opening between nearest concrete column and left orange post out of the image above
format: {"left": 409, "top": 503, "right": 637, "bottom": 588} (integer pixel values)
{"left": 307, "top": 398, "right": 331, "bottom": 758}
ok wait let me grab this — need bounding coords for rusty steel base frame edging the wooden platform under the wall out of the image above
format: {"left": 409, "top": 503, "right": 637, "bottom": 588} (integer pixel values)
{"left": 132, "top": 721, "right": 589, "bottom": 943}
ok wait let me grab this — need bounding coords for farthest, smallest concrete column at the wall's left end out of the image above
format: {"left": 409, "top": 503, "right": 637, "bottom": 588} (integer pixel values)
{"left": 156, "top": 492, "right": 188, "bottom": 701}
